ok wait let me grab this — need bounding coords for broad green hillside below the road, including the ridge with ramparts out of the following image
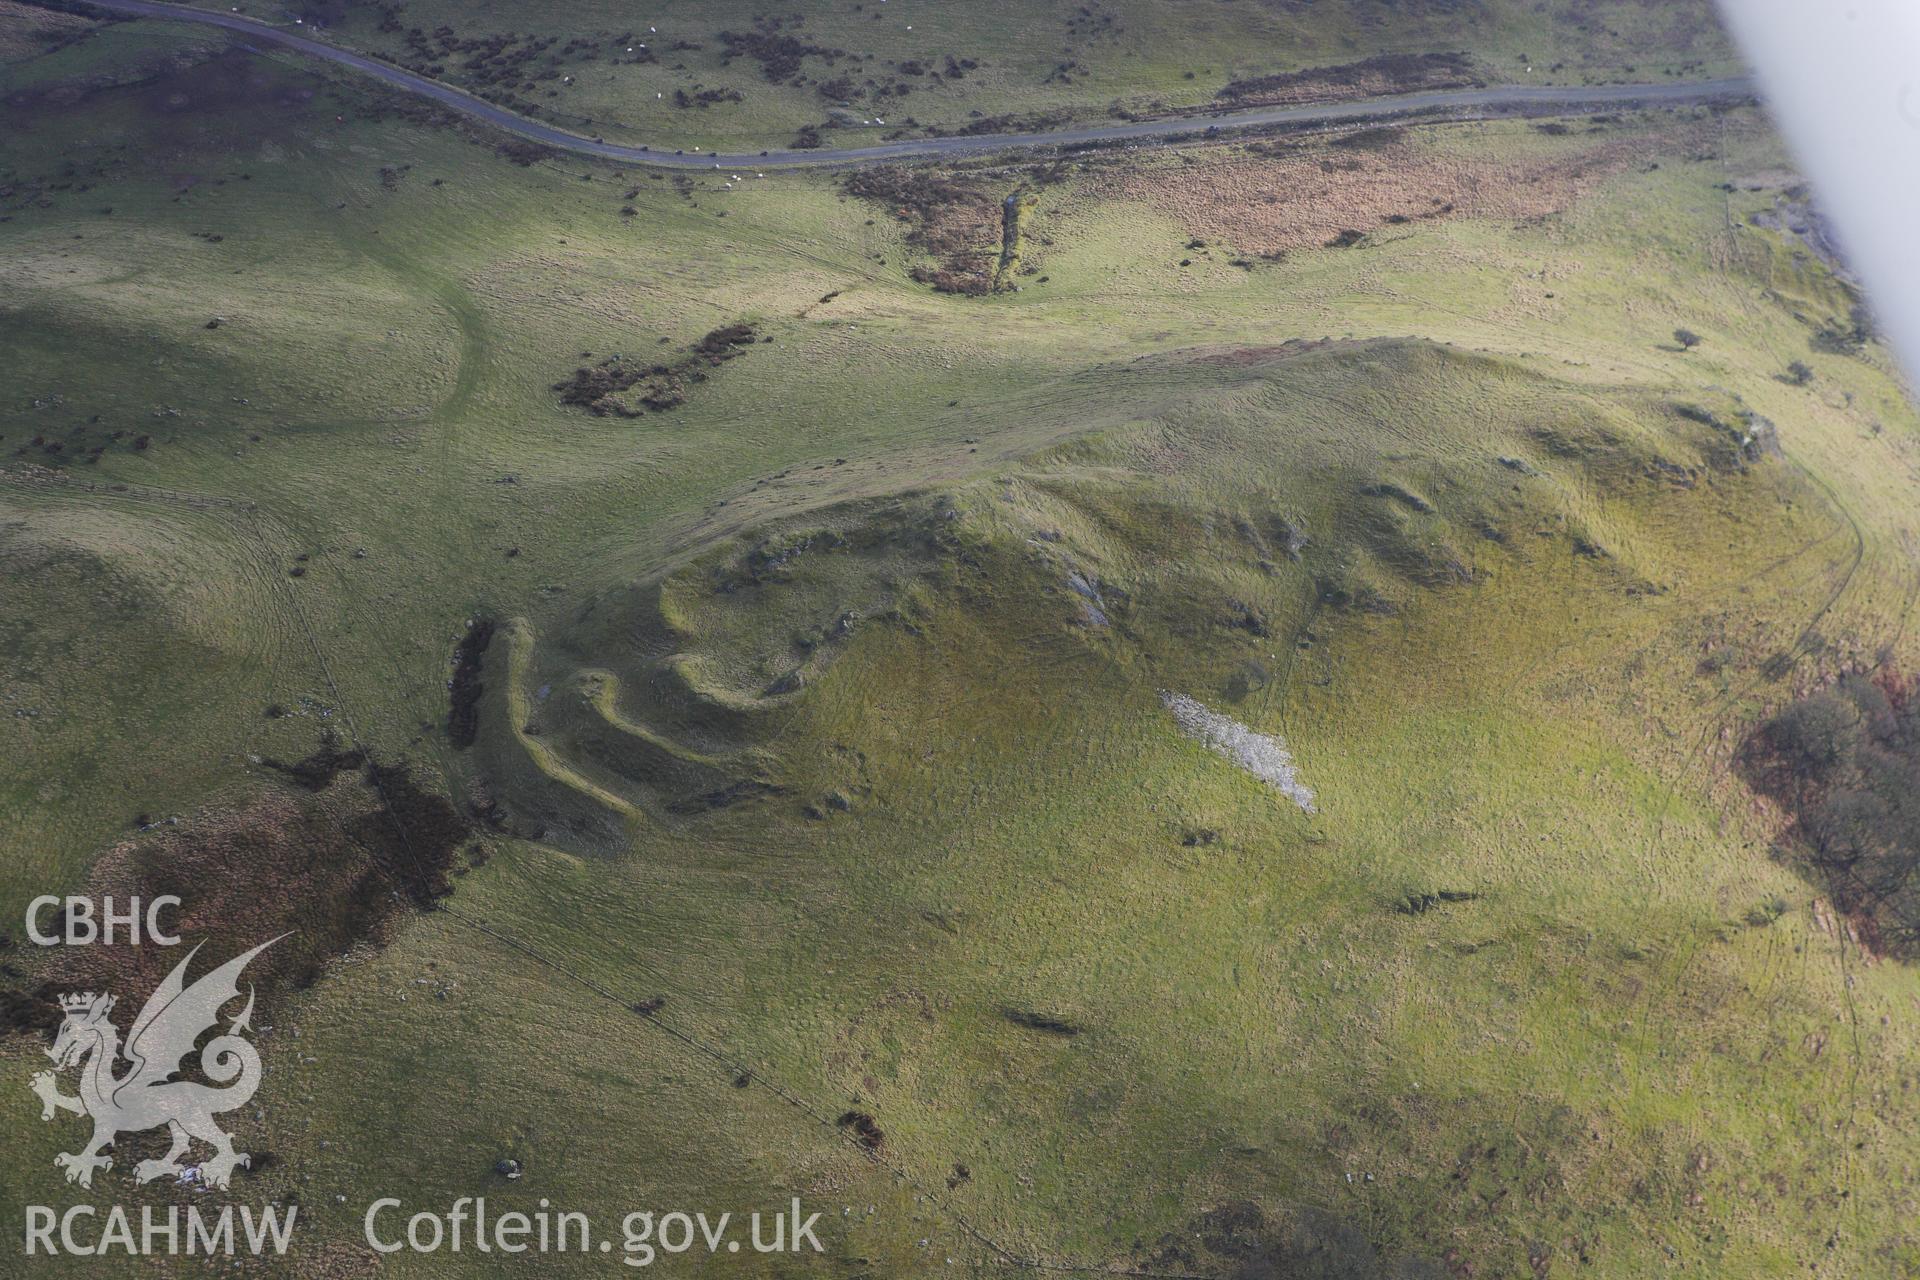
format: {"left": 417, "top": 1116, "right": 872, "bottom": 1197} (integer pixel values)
{"left": 0, "top": 21, "right": 1920, "bottom": 1278}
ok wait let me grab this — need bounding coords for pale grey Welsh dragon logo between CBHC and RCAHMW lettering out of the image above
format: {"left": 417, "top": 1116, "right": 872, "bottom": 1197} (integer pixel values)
{"left": 33, "top": 935, "right": 286, "bottom": 1190}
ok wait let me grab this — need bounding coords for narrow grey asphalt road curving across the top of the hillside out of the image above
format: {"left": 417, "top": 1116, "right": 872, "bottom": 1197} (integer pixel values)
{"left": 71, "top": 0, "right": 1755, "bottom": 169}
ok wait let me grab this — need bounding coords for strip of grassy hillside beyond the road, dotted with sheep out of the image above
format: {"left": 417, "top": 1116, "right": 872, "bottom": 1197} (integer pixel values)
{"left": 153, "top": 0, "right": 1736, "bottom": 150}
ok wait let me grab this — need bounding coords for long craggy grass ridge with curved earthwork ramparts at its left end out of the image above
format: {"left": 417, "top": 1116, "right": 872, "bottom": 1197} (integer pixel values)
{"left": 482, "top": 340, "right": 1795, "bottom": 841}
